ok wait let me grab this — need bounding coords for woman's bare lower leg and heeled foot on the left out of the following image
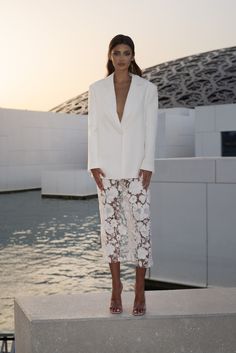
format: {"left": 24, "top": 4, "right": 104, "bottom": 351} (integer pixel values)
{"left": 109, "top": 262, "right": 123, "bottom": 314}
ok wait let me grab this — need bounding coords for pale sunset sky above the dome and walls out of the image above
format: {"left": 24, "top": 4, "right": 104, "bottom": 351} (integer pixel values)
{"left": 0, "top": 0, "right": 236, "bottom": 111}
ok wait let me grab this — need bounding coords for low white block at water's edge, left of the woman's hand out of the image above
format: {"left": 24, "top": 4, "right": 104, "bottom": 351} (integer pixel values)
{"left": 41, "top": 169, "right": 97, "bottom": 197}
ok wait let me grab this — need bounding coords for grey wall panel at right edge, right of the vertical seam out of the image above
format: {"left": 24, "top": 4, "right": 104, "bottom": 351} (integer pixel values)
{"left": 207, "top": 184, "right": 236, "bottom": 287}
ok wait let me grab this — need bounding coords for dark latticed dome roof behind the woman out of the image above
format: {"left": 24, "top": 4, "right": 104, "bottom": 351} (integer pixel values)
{"left": 50, "top": 47, "right": 236, "bottom": 114}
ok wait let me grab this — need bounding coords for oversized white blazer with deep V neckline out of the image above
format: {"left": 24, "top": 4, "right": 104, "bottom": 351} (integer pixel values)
{"left": 88, "top": 72, "right": 158, "bottom": 179}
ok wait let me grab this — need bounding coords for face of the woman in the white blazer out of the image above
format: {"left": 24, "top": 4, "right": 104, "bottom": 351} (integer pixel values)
{"left": 110, "top": 44, "right": 133, "bottom": 71}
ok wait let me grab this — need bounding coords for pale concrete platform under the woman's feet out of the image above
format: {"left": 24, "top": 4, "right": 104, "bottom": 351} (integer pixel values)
{"left": 15, "top": 288, "right": 236, "bottom": 353}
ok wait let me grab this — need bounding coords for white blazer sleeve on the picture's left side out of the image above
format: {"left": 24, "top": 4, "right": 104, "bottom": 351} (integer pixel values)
{"left": 88, "top": 85, "right": 100, "bottom": 170}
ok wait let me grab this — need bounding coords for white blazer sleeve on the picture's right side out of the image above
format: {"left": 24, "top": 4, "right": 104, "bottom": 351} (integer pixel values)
{"left": 140, "top": 84, "right": 158, "bottom": 174}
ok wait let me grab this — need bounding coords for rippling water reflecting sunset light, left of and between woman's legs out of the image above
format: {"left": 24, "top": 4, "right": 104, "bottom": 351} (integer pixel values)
{"left": 0, "top": 191, "right": 134, "bottom": 332}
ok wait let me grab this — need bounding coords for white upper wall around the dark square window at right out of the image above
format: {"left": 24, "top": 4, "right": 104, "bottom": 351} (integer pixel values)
{"left": 195, "top": 104, "right": 236, "bottom": 157}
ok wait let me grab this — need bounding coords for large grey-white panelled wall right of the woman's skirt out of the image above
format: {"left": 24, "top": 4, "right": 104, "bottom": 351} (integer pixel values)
{"left": 150, "top": 157, "right": 236, "bottom": 287}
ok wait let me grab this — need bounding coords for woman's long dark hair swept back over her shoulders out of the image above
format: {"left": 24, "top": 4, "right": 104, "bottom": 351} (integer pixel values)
{"left": 106, "top": 34, "right": 142, "bottom": 76}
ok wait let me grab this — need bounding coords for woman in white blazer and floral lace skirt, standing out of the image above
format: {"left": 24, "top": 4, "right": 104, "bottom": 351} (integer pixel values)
{"left": 88, "top": 34, "right": 158, "bottom": 315}
